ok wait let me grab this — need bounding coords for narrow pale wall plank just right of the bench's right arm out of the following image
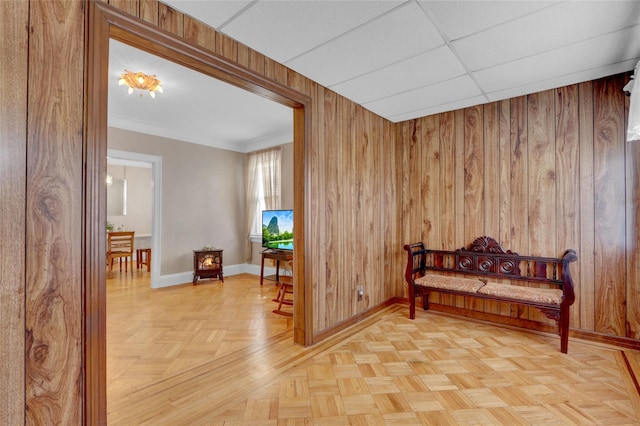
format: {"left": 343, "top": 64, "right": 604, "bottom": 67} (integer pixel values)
{"left": 572, "top": 81, "right": 596, "bottom": 330}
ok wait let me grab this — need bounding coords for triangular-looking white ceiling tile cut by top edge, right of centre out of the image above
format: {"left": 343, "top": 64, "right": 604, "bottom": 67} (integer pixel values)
{"left": 419, "top": 1, "right": 557, "bottom": 40}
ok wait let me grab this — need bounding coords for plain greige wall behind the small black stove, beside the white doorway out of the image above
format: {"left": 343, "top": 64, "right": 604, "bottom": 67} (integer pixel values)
{"left": 107, "top": 127, "right": 245, "bottom": 276}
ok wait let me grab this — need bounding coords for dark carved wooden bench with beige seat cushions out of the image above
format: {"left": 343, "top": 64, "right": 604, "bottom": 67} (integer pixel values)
{"left": 404, "top": 237, "right": 578, "bottom": 353}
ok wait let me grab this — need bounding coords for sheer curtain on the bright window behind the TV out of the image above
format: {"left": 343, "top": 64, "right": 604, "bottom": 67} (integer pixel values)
{"left": 245, "top": 147, "right": 282, "bottom": 260}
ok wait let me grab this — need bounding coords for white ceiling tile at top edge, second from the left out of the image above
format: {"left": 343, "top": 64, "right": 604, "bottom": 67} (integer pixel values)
{"left": 222, "top": 0, "right": 402, "bottom": 63}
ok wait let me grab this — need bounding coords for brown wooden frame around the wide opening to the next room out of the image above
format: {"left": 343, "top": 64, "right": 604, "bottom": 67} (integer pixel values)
{"left": 83, "top": 1, "right": 313, "bottom": 424}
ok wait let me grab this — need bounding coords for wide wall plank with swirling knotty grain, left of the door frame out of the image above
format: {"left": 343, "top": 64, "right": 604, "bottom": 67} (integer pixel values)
{"left": 25, "top": 1, "right": 86, "bottom": 425}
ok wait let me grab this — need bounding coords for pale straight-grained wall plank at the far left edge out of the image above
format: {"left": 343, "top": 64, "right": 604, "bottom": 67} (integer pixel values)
{"left": 0, "top": 1, "right": 29, "bottom": 425}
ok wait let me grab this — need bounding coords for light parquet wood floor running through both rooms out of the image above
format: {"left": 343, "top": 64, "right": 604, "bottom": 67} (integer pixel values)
{"left": 107, "top": 273, "right": 640, "bottom": 425}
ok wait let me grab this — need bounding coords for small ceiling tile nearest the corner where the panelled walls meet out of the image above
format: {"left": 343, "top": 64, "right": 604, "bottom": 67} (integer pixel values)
{"left": 363, "top": 75, "right": 481, "bottom": 117}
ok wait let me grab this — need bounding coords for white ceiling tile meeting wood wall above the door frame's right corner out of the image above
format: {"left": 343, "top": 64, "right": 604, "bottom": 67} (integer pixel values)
{"left": 285, "top": 2, "right": 444, "bottom": 86}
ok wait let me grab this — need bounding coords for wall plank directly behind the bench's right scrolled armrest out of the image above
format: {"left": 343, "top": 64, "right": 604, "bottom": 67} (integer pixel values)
{"left": 553, "top": 85, "right": 580, "bottom": 328}
